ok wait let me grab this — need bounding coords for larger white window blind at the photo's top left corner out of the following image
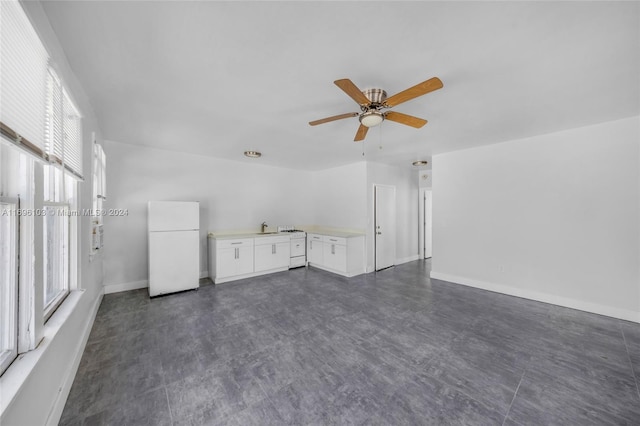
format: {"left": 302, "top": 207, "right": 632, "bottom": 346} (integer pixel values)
{"left": 0, "top": 0, "right": 49, "bottom": 156}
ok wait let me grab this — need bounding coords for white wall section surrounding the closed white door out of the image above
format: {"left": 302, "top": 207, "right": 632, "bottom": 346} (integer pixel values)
{"left": 367, "top": 162, "right": 419, "bottom": 272}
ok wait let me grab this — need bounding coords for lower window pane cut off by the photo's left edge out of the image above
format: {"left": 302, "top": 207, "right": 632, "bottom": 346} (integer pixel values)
{"left": 0, "top": 197, "right": 19, "bottom": 374}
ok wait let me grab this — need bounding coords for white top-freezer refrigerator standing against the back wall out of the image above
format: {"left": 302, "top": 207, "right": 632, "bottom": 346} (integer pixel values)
{"left": 148, "top": 201, "right": 200, "bottom": 297}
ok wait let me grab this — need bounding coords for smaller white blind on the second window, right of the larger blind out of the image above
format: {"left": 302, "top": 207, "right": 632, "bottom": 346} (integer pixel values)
{"left": 45, "top": 68, "right": 82, "bottom": 177}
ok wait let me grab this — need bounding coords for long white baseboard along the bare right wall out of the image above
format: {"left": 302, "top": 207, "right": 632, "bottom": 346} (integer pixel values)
{"left": 431, "top": 271, "right": 640, "bottom": 323}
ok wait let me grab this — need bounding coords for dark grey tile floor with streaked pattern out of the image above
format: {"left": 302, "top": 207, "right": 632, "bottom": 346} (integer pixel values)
{"left": 61, "top": 261, "right": 640, "bottom": 426}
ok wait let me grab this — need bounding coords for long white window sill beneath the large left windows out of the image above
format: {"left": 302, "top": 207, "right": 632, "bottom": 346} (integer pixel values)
{"left": 0, "top": 290, "right": 85, "bottom": 416}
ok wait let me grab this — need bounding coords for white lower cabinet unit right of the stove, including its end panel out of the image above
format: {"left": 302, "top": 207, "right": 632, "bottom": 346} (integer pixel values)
{"left": 307, "top": 234, "right": 365, "bottom": 277}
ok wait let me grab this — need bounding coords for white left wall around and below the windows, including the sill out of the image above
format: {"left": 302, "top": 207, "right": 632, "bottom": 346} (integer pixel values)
{"left": 0, "top": 2, "right": 103, "bottom": 426}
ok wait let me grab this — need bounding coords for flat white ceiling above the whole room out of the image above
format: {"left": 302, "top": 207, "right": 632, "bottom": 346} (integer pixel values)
{"left": 43, "top": 1, "right": 640, "bottom": 170}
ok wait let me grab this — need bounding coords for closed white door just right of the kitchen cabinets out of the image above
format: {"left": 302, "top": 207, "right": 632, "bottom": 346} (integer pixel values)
{"left": 374, "top": 185, "right": 396, "bottom": 271}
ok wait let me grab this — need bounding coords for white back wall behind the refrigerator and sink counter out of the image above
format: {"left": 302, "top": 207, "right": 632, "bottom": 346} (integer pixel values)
{"left": 104, "top": 141, "right": 313, "bottom": 291}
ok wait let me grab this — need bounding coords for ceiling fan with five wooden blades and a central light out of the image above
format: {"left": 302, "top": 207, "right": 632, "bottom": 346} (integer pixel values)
{"left": 309, "top": 77, "right": 443, "bottom": 142}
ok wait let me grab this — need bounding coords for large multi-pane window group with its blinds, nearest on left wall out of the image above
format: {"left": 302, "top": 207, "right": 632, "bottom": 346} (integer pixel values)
{"left": 0, "top": 0, "right": 83, "bottom": 374}
